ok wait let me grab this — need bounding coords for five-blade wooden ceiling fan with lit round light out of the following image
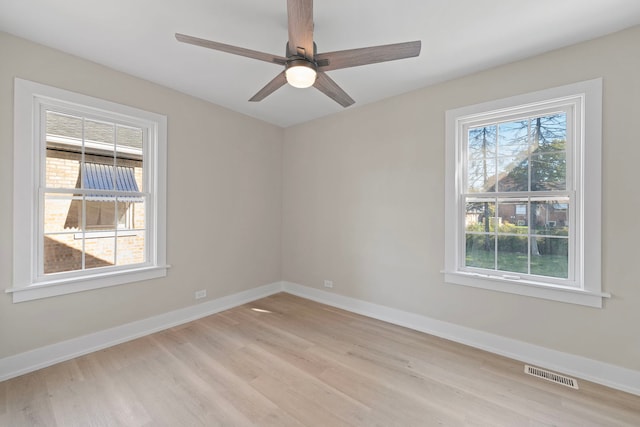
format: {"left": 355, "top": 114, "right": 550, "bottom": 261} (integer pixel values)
{"left": 176, "top": 0, "right": 421, "bottom": 107}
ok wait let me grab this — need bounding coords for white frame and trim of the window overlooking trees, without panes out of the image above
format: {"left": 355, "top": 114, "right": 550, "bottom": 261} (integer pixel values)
{"left": 444, "top": 79, "right": 611, "bottom": 307}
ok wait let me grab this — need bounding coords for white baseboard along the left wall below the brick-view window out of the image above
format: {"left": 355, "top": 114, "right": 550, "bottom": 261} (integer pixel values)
{"left": 0, "top": 282, "right": 282, "bottom": 381}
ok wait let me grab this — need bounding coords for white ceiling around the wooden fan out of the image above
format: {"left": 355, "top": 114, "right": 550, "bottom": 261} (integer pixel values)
{"left": 0, "top": 0, "right": 640, "bottom": 127}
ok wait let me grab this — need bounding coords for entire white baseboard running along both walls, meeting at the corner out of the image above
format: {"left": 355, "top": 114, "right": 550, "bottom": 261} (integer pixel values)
{"left": 0, "top": 282, "right": 640, "bottom": 396}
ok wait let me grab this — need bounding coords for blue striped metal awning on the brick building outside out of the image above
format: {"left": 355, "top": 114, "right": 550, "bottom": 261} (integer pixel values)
{"left": 82, "top": 163, "right": 143, "bottom": 202}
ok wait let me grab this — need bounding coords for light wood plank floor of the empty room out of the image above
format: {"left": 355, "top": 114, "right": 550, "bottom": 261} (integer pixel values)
{"left": 0, "top": 294, "right": 640, "bottom": 427}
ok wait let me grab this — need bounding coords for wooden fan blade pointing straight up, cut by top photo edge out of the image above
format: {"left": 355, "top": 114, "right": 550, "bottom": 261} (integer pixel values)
{"left": 287, "top": 0, "right": 314, "bottom": 59}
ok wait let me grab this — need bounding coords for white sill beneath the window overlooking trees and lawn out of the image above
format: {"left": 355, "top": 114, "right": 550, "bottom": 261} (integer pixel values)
{"left": 443, "top": 271, "right": 611, "bottom": 308}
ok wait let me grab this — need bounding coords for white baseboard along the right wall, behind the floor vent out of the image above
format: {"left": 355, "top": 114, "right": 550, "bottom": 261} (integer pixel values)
{"left": 282, "top": 282, "right": 640, "bottom": 396}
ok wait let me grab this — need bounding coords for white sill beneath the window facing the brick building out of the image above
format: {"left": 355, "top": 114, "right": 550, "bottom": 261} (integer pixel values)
{"left": 5, "top": 265, "right": 170, "bottom": 303}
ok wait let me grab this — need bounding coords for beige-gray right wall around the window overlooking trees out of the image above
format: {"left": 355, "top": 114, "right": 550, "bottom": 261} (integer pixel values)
{"left": 282, "top": 27, "right": 640, "bottom": 370}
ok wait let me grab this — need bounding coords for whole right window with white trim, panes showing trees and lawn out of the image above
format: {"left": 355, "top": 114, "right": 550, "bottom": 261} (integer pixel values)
{"left": 445, "top": 79, "right": 609, "bottom": 307}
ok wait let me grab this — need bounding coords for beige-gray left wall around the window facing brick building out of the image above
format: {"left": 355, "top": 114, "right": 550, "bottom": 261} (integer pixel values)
{"left": 0, "top": 33, "right": 283, "bottom": 358}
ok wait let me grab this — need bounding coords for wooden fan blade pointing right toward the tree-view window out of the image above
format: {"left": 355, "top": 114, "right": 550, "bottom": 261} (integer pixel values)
{"left": 315, "top": 40, "right": 422, "bottom": 71}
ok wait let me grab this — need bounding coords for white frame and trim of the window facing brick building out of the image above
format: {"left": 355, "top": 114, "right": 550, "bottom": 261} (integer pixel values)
{"left": 6, "top": 78, "right": 168, "bottom": 303}
